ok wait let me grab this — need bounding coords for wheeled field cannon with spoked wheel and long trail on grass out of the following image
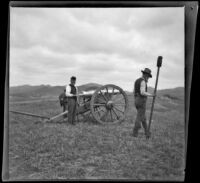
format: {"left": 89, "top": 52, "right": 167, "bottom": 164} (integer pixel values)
{"left": 10, "top": 84, "right": 128, "bottom": 124}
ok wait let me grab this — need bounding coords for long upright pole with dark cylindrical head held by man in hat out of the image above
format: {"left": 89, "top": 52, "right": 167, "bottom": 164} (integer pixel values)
{"left": 148, "top": 56, "right": 162, "bottom": 135}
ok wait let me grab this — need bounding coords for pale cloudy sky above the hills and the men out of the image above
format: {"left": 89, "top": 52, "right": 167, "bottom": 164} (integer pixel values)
{"left": 10, "top": 7, "right": 185, "bottom": 91}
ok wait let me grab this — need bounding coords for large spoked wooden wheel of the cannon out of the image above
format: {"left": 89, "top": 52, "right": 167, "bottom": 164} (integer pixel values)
{"left": 90, "top": 84, "right": 128, "bottom": 124}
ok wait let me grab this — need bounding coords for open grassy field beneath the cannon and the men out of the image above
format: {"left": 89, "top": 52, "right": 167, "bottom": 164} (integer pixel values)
{"left": 9, "top": 95, "right": 185, "bottom": 180}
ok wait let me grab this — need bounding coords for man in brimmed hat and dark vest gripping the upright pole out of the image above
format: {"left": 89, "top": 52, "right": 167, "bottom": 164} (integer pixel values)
{"left": 133, "top": 68, "right": 154, "bottom": 138}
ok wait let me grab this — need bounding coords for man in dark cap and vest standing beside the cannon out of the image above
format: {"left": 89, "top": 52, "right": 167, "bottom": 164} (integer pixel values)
{"left": 65, "top": 76, "right": 78, "bottom": 124}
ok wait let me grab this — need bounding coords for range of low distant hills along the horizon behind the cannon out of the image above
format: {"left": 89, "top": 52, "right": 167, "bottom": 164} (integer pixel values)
{"left": 10, "top": 83, "right": 184, "bottom": 100}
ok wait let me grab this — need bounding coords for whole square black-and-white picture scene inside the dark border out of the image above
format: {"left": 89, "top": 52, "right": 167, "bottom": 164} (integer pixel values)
{"left": 2, "top": 1, "right": 198, "bottom": 181}
